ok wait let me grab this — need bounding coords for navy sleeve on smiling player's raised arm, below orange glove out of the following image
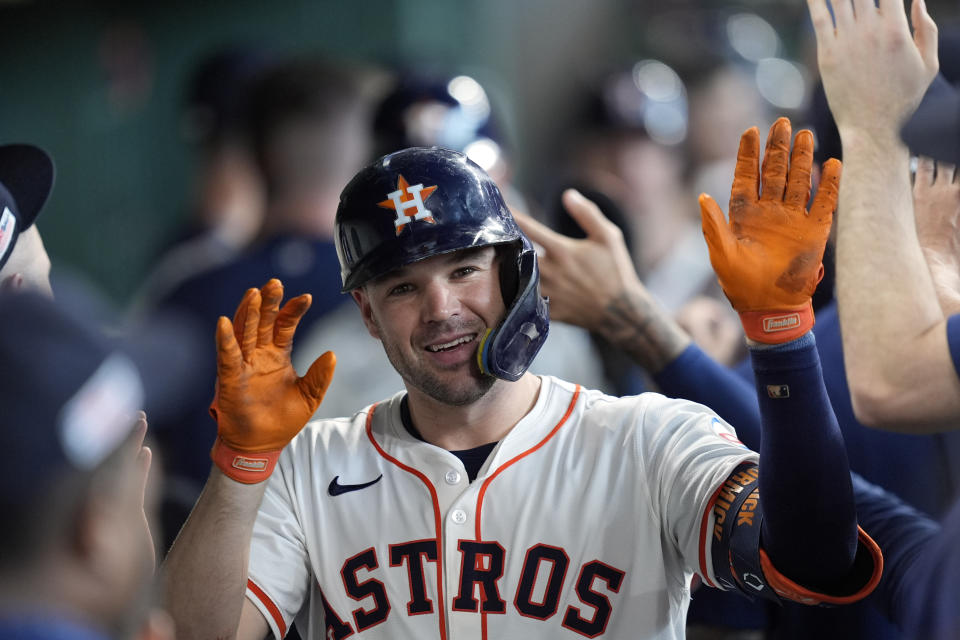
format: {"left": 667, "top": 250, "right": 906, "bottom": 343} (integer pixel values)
{"left": 750, "top": 333, "right": 857, "bottom": 588}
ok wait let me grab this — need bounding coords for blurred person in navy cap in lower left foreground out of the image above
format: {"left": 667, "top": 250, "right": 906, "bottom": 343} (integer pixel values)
{"left": 0, "top": 288, "right": 172, "bottom": 640}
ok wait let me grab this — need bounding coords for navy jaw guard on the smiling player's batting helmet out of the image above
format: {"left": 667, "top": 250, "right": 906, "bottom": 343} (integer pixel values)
{"left": 477, "top": 248, "right": 550, "bottom": 381}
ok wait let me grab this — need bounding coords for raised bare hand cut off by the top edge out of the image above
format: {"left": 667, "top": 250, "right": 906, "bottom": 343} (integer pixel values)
{"left": 807, "top": 0, "right": 939, "bottom": 136}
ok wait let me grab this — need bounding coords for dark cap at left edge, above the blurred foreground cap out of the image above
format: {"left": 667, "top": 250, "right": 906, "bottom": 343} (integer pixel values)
{"left": 0, "top": 144, "right": 54, "bottom": 269}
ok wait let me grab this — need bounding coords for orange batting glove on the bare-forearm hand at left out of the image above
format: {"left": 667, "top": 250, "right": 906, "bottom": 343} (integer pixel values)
{"left": 210, "top": 278, "right": 337, "bottom": 484}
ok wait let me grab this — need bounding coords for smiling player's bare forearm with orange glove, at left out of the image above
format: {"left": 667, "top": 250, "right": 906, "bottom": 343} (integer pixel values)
{"left": 164, "top": 280, "right": 335, "bottom": 639}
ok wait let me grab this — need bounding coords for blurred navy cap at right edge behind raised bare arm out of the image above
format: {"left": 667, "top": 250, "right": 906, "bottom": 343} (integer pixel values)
{"left": 900, "top": 74, "right": 960, "bottom": 164}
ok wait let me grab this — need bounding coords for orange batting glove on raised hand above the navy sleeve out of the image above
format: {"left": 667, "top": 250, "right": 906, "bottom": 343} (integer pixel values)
{"left": 700, "top": 118, "right": 841, "bottom": 344}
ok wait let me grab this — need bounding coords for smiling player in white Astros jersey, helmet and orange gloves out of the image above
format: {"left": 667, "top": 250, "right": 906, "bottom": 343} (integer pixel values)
{"left": 166, "top": 119, "right": 882, "bottom": 639}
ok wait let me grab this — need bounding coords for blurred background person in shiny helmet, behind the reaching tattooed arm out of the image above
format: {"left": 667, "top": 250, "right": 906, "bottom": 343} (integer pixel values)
{"left": 552, "top": 59, "right": 714, "bottom": 311}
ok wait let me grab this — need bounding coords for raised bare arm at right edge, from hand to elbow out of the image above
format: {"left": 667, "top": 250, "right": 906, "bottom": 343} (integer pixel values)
{"left": 807, "top": 0, "right": 960, "bottom": 433}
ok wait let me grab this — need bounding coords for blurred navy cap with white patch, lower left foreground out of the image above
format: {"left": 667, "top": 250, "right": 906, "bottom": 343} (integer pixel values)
{"left": 0, "top": 291, "right": 144, "bottom": 505}
